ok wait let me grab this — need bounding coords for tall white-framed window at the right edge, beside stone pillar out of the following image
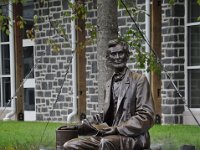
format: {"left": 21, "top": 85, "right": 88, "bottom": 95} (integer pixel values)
{"left": 185, "top": 0, "right": 200, "bottom": 108}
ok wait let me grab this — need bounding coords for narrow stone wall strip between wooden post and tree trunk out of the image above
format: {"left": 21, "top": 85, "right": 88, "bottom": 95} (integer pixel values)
{"left": 86, "top": 0, "right": 98, "bottom": 117}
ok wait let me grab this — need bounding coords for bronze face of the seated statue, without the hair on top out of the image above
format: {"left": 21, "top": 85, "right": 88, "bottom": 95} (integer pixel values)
{"left": 108, "top": 44, "right": 127, "bottom": 69}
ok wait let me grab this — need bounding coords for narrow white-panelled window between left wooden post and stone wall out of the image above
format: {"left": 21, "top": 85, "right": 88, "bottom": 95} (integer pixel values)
{"left": 23, "top": 0, "right": 36, "bottom": 121}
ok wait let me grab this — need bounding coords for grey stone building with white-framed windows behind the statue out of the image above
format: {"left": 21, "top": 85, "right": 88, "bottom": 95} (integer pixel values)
{"left": 0, "top": 0, "right": 200, "bottom": 124}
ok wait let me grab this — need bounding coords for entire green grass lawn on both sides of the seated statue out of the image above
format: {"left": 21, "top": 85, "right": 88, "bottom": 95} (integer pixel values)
{"left": 0, "top": 121, "right": 200, "bottom": 150}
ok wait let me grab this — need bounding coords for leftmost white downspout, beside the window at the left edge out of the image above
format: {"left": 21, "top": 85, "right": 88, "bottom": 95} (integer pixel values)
{"left": 3, "top": 0, "right": 16, "bottom": 120}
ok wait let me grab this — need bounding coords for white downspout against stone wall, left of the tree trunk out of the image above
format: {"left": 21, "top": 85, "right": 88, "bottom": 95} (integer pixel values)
{"left": 67, "top": 0, "right": 78, "bottom": 123}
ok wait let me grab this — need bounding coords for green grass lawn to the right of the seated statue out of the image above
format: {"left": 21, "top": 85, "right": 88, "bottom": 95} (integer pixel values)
{"left": 150, "top": 125, "right": 200, "bottom": 150}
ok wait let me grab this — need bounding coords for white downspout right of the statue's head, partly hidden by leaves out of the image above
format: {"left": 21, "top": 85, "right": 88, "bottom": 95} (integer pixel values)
{"left": 145, "top": 0, "right": 151, "bottom": 82}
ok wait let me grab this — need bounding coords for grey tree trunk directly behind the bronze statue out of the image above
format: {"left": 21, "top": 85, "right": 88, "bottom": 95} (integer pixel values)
{"left": 97, "top": 0, "right": 118, "bottom": 111}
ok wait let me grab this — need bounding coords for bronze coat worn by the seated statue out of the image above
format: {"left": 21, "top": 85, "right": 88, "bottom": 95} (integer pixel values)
{"left": 104, "top": 69, "right": 154, "bottom": 147}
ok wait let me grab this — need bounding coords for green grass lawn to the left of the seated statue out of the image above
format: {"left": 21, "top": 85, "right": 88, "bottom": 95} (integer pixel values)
{"left": 0, "top": 121, "right": 63, "bottom": 150}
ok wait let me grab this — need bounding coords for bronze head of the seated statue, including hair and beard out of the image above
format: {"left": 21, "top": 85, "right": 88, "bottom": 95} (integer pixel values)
{"left": 106, "top": 39, "right": 130, "bottom": 69}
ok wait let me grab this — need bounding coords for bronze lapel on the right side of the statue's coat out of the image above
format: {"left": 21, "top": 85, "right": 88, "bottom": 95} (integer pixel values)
{"left": 116, "top": 70, "right": 130, "bottom": 114}
